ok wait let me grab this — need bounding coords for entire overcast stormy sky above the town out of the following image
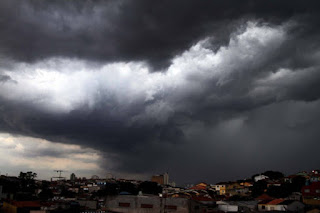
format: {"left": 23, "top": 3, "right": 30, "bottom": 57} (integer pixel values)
{"left": 0, "top": 0, "right": 320, "bottom": 184}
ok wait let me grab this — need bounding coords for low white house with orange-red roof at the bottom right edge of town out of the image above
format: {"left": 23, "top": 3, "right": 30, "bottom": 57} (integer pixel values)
{"left": 258, "top": 199, "right": 304, "bottom": 212}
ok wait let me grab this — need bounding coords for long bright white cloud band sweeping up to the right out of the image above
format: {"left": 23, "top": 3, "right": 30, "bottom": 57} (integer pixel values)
{"left": 0, "top": 22, "right": 285, "bottom": 123}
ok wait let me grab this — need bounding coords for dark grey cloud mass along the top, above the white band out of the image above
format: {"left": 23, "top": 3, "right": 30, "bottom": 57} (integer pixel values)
{"left": 0, "top": 0, "right": 319, "bottom": 68}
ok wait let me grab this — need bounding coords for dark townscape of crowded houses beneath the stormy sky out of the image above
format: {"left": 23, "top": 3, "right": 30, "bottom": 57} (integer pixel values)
{"left": 0, "top": 170, "right": 320, "bottom": 213}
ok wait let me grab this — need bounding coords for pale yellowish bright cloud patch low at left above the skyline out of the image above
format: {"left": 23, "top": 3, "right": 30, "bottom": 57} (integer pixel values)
{"left": 0, "top": 134, "right": 102, "bottom": 179}
